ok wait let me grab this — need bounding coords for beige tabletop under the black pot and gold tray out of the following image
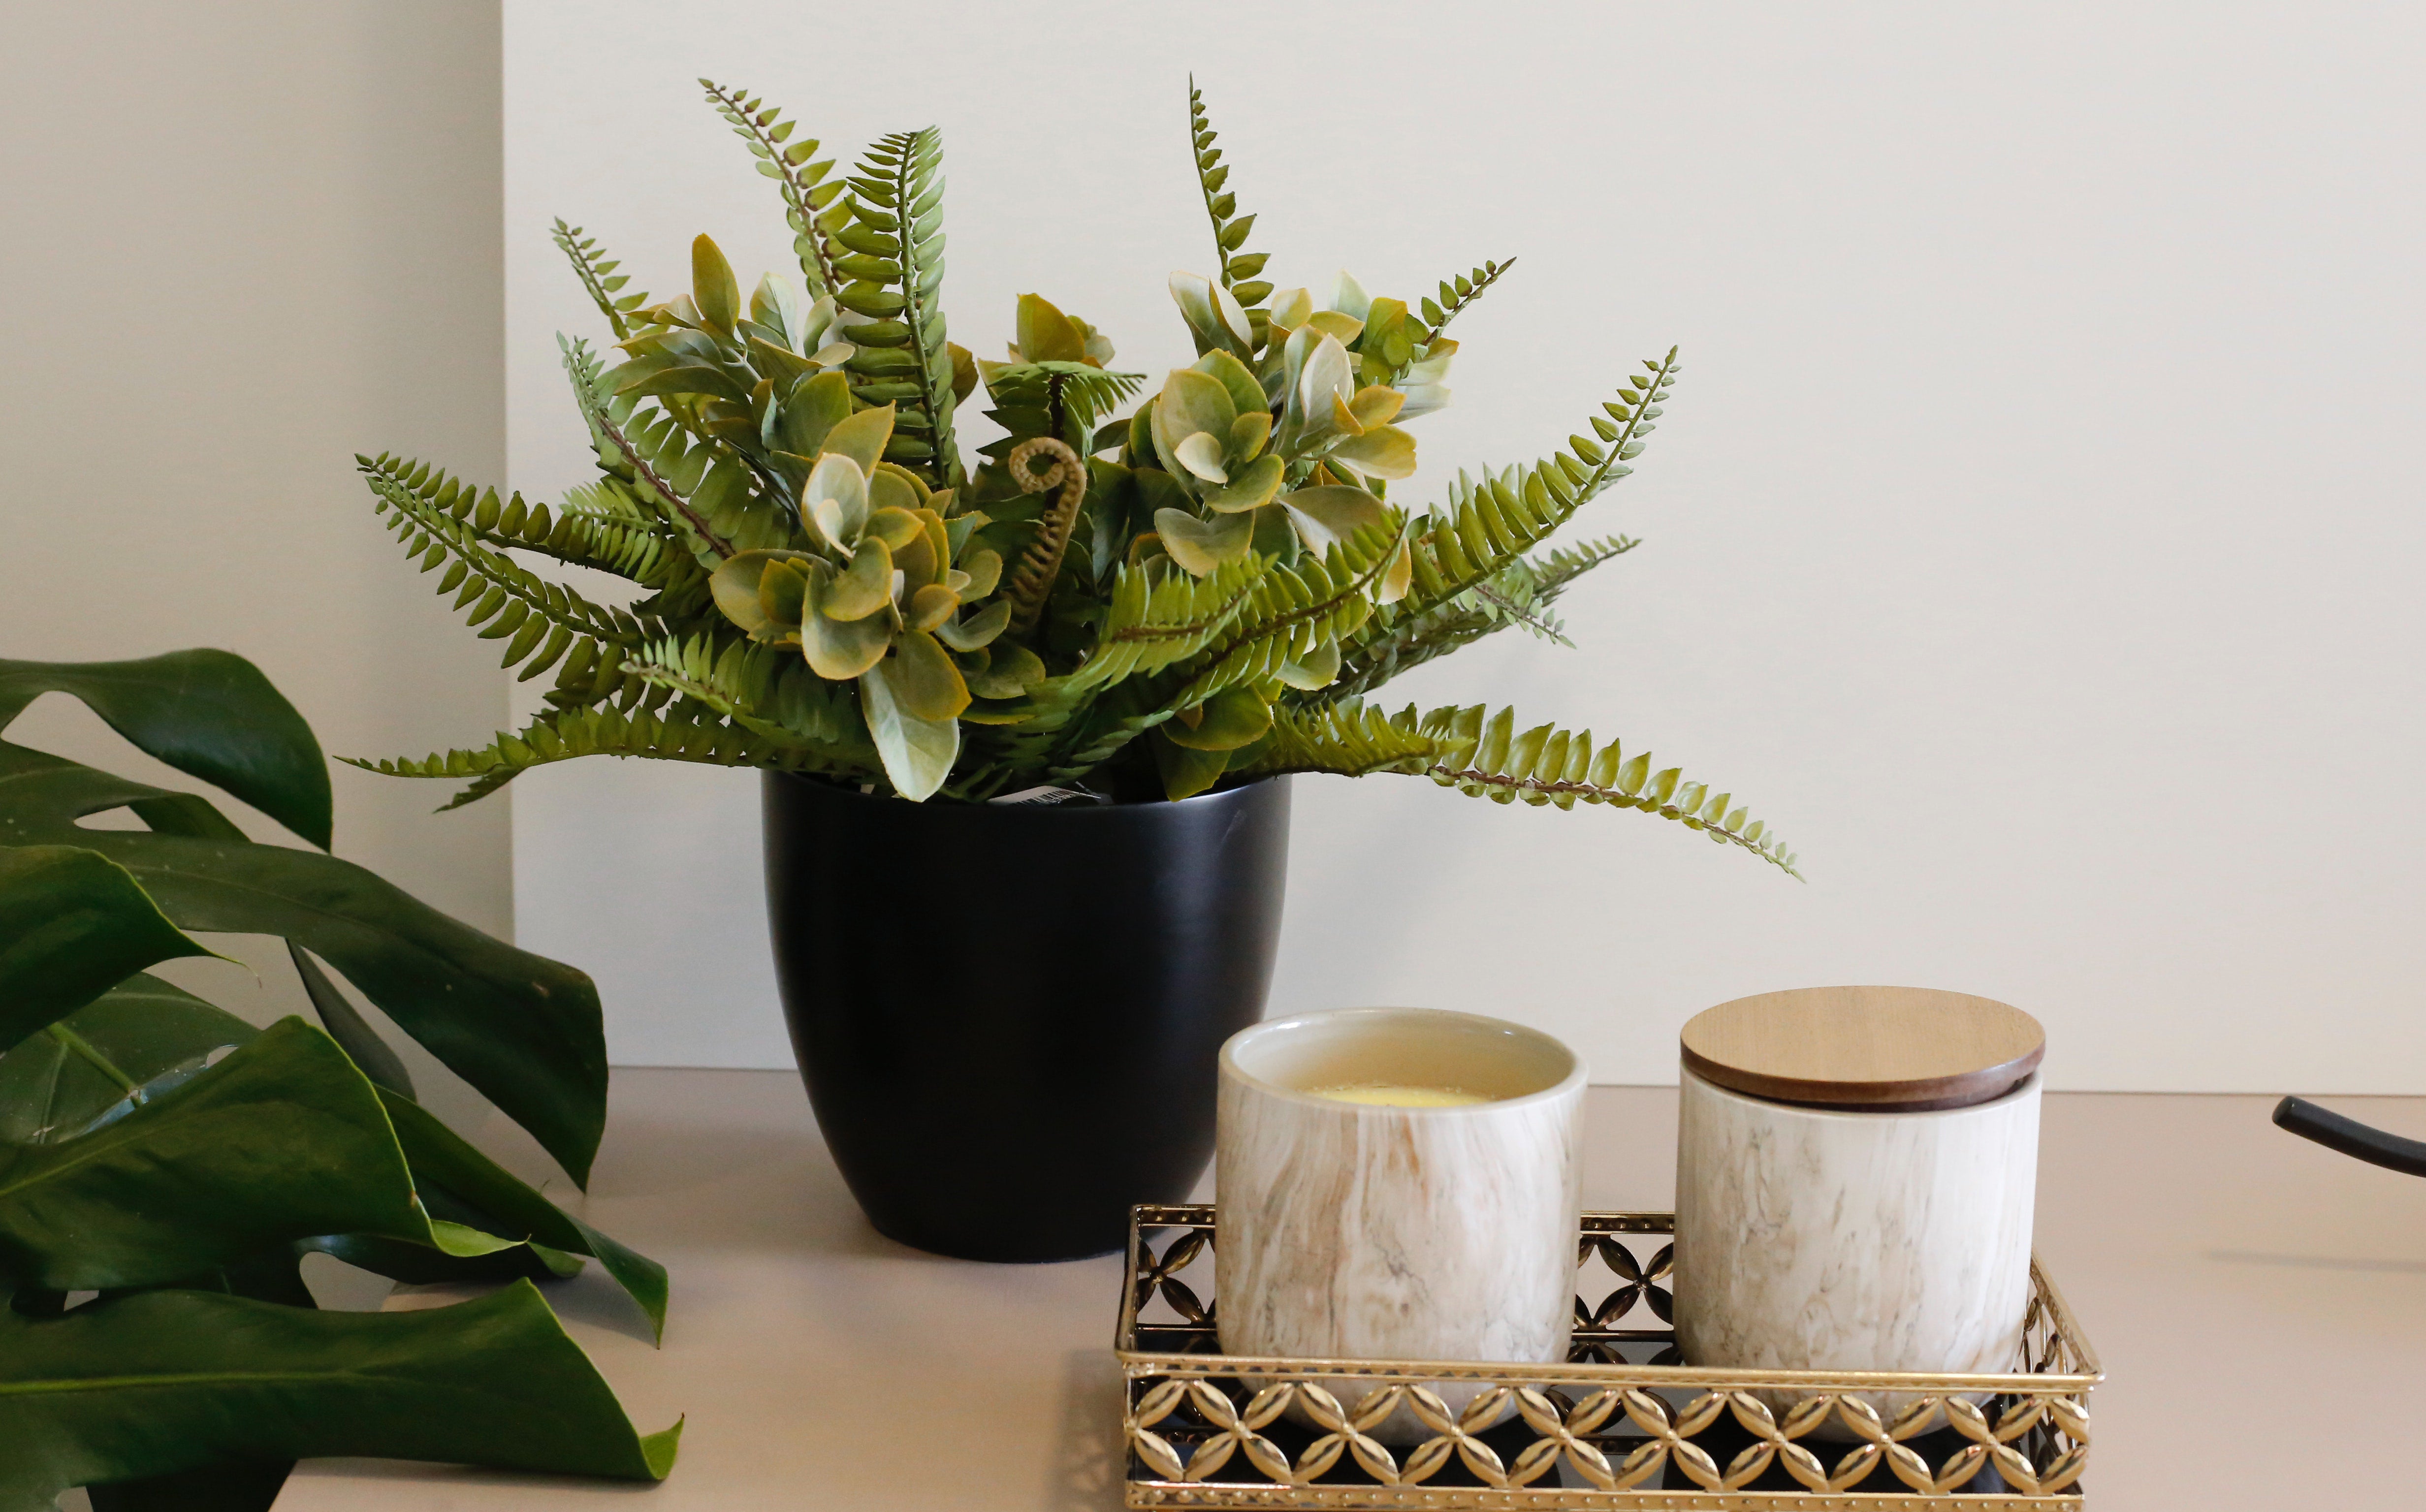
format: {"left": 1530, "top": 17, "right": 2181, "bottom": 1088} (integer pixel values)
{"left": 265, "top": 1071, "right": 2426, "bottom": 1512}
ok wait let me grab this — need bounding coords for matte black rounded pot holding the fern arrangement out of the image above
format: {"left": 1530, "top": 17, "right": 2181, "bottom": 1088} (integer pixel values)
{"left": 764, "top": 772, "right": 1288, "bottom": 1260}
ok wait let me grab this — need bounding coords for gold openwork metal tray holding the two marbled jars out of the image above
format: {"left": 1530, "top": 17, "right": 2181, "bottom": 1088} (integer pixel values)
{"left": 1114, "top": 1206, "right": 2106, "bottom": 1512}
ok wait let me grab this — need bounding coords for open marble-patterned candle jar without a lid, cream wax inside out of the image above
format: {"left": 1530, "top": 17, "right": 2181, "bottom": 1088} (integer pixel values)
{"left": 1213, "top": 1007, "right": 1584, "bottom": 1415}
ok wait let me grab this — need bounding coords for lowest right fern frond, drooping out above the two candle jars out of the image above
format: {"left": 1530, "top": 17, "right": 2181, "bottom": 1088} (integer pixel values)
{"left": 1400, "top": 704, "right": 1803, "bottom": 881}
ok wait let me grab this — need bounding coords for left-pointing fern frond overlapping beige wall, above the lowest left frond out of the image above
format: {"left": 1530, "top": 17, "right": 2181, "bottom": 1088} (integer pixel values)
{"left": 356, "top": 456, "right": 657, "bottom": 680}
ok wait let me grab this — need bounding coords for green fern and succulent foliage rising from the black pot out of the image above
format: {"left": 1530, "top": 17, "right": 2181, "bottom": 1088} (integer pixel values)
{"left": 359, "top": 80, "right": 1795, "bottom": 871}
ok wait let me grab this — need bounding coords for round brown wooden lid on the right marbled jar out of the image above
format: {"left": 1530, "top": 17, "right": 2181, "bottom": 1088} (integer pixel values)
{"left": 1679, "top": 988, "right": 2047, "bottom": 1114}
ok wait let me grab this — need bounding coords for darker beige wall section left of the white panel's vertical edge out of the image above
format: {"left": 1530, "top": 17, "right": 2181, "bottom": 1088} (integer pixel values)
{"left": 0, "top": 0, "right": 512, "bottom": 1111}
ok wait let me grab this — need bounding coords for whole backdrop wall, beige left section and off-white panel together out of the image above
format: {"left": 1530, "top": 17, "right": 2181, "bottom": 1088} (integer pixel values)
{"left": 0, "top": 0, "right": 2426, "bottom": 1092}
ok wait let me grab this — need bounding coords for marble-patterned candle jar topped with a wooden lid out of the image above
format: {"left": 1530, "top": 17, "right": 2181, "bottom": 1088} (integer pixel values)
{"left": 1676, "top": 988, "right": 2045, "bottom": 1413}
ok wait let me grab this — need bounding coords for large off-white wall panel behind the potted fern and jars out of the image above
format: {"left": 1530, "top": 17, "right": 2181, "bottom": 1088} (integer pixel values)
{"left": 505, "top": 0, "right": 2426, "bottom": 1092}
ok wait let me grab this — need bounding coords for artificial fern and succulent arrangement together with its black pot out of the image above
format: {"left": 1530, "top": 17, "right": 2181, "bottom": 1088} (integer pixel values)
{"left": 359, "top": 80, "right": 1795, "bottom": 1260}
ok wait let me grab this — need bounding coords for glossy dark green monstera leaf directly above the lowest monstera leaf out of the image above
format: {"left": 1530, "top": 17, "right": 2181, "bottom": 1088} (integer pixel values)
{"left": 0, "top": 976, "right": 667, "bottom": 1335}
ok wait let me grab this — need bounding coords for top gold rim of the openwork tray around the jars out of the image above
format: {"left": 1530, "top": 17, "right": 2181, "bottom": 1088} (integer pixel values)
{"left": 1111, "top": 1204, "right": 2106, "bottom": 1398}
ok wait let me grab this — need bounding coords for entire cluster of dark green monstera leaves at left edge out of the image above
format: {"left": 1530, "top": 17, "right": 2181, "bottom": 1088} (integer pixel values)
{"left": 0, "top": 651, "right": 679, "bottom": 1512}
